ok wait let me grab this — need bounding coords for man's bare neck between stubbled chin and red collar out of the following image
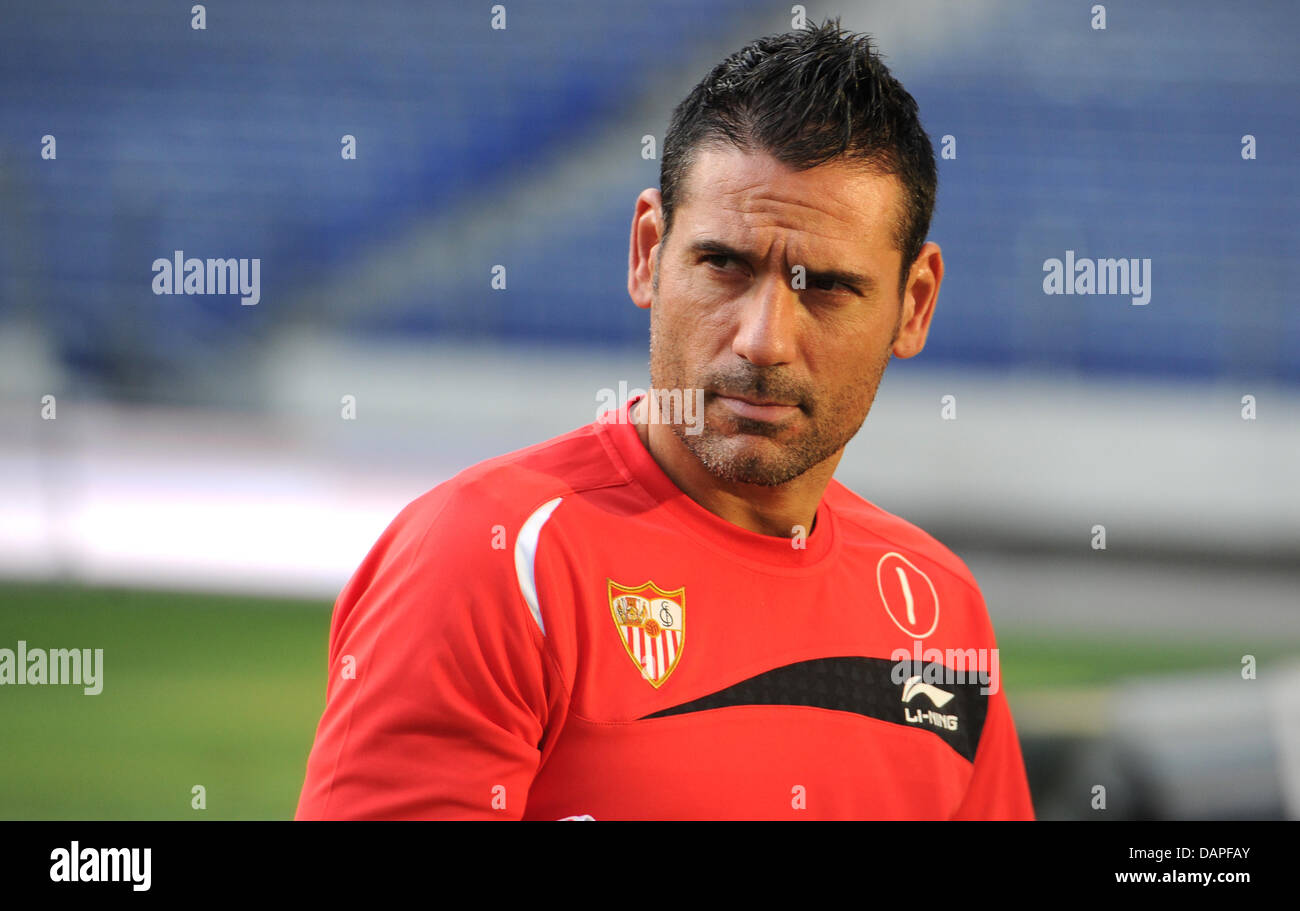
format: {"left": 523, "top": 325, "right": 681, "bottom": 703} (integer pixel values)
{"left": 631, "top": 399, "right": 844, "bottom": 538}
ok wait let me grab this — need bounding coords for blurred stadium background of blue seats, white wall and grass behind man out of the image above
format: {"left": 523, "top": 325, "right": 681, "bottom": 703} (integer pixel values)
{"left": 0, "top": 0, "right": 1300, "bottom": 819}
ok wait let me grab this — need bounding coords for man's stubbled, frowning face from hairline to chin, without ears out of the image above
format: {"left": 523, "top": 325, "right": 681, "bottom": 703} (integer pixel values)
{"left": 650, "top": 147, "right": 928, "bottom": 486}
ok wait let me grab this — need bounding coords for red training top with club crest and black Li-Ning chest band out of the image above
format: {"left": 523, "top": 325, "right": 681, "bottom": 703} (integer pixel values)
{"left": 296, "top": 403, "right": 1034, "bottom": 820}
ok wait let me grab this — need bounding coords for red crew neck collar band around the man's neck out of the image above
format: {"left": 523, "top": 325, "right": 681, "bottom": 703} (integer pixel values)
{"left": 597, "top": 395, "right": 837, "bottom": 569}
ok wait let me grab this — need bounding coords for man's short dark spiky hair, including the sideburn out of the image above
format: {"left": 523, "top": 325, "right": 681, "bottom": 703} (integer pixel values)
{"left": 659, "top": 18, "right": 939, "bottom": 292}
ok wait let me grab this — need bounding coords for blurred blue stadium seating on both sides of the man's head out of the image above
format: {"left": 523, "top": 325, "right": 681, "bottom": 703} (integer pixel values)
{"left": 0, "top": 0, "right": 1300, "bottom": 395}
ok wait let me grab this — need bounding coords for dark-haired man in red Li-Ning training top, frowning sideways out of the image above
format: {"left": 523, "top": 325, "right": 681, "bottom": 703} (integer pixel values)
{"left": 298, "top": 22, "right": 1032, "bottom": 820}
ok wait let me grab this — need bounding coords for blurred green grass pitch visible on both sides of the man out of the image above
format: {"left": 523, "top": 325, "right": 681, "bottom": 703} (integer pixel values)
{"left": 0, "top": 582, "right": 1294, "bottom": 820}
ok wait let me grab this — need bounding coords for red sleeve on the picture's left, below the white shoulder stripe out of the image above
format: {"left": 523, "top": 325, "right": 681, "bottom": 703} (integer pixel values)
{"left": 296, "top": 491, "right": 554, "bottom": 819}
